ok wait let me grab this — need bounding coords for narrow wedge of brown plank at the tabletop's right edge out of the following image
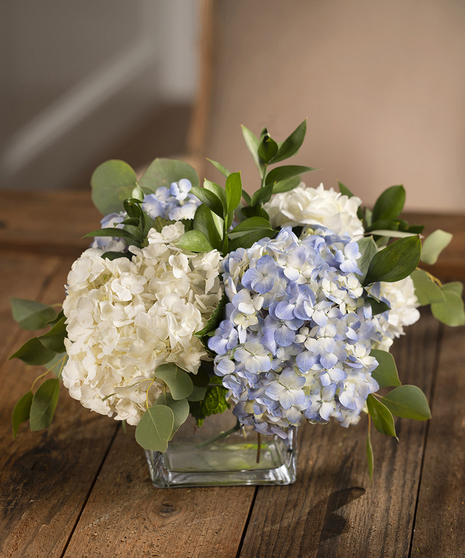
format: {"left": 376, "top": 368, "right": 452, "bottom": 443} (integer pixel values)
{"left": 412, "top": 327, "right": 465, "bottom": 558}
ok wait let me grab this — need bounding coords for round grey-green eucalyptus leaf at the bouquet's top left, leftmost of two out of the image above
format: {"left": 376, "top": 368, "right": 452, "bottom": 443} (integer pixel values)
{"left": 90, "top": 159, "right": 137, "bottom": 215}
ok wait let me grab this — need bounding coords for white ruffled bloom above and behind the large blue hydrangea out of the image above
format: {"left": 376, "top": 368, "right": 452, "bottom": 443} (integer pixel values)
{"left": 263, "top": 182, "right": 364, "bottom": 238}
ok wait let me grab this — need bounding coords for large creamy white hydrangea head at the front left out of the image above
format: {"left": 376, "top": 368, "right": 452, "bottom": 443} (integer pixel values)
{"left": 63, "top": 222, "right": 222, "bottom": 425}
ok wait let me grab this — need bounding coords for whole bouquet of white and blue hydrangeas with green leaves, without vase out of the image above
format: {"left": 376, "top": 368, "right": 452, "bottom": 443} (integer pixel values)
{"left": 11, "top": 121, "right": 465, "bottom": 475}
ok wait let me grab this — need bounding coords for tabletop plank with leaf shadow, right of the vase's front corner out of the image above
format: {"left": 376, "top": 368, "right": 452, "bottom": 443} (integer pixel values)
{"left": 240, "top": 315, "right": 439, "bottom": 558}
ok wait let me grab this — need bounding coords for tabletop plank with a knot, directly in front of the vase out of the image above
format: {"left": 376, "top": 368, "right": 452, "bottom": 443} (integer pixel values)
{"left": 60, "top": 429, "right": 255, "bottom": 558}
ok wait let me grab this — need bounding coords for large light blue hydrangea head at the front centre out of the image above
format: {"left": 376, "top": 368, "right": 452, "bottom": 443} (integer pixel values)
{"left": 209, "top": 227, "right": 382, "bottom": 438}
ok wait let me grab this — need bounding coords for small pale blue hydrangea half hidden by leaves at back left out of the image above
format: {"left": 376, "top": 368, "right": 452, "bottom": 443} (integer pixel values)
{"left": 92, "top": 178, "right": 201, "bottom": 252}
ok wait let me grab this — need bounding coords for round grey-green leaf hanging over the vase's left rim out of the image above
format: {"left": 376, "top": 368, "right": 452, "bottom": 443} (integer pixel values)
{"left": 136, "top": 405, "right": 174, "bottom": 453}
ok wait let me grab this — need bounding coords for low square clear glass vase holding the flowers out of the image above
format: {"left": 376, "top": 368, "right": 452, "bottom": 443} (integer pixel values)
{"left": 146, "top": 410, "right": 297, "bottom": 488}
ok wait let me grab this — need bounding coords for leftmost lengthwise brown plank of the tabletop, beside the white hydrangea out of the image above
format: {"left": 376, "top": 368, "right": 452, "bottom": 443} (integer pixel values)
{"left": 0, "top": 255, "right": 116, "bottom": 558}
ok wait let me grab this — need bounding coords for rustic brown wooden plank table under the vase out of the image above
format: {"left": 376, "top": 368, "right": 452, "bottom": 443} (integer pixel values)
{"left": 0, "top": 192, "right": 465, "bottom": 558}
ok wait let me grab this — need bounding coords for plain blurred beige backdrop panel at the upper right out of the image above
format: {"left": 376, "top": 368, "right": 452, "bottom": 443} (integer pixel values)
{"left": 206, "top": 0, "right": 465, "bottom": 212}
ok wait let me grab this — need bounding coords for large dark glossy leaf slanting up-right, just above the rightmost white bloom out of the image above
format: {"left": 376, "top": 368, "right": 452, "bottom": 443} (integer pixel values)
{"left": 363, "top": 236, "right": 421, "bottom": 285}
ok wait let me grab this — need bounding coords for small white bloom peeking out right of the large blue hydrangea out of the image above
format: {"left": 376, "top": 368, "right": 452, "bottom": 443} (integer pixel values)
{"left": 375, "top": 276, "right": 420, "bottom": 351}
